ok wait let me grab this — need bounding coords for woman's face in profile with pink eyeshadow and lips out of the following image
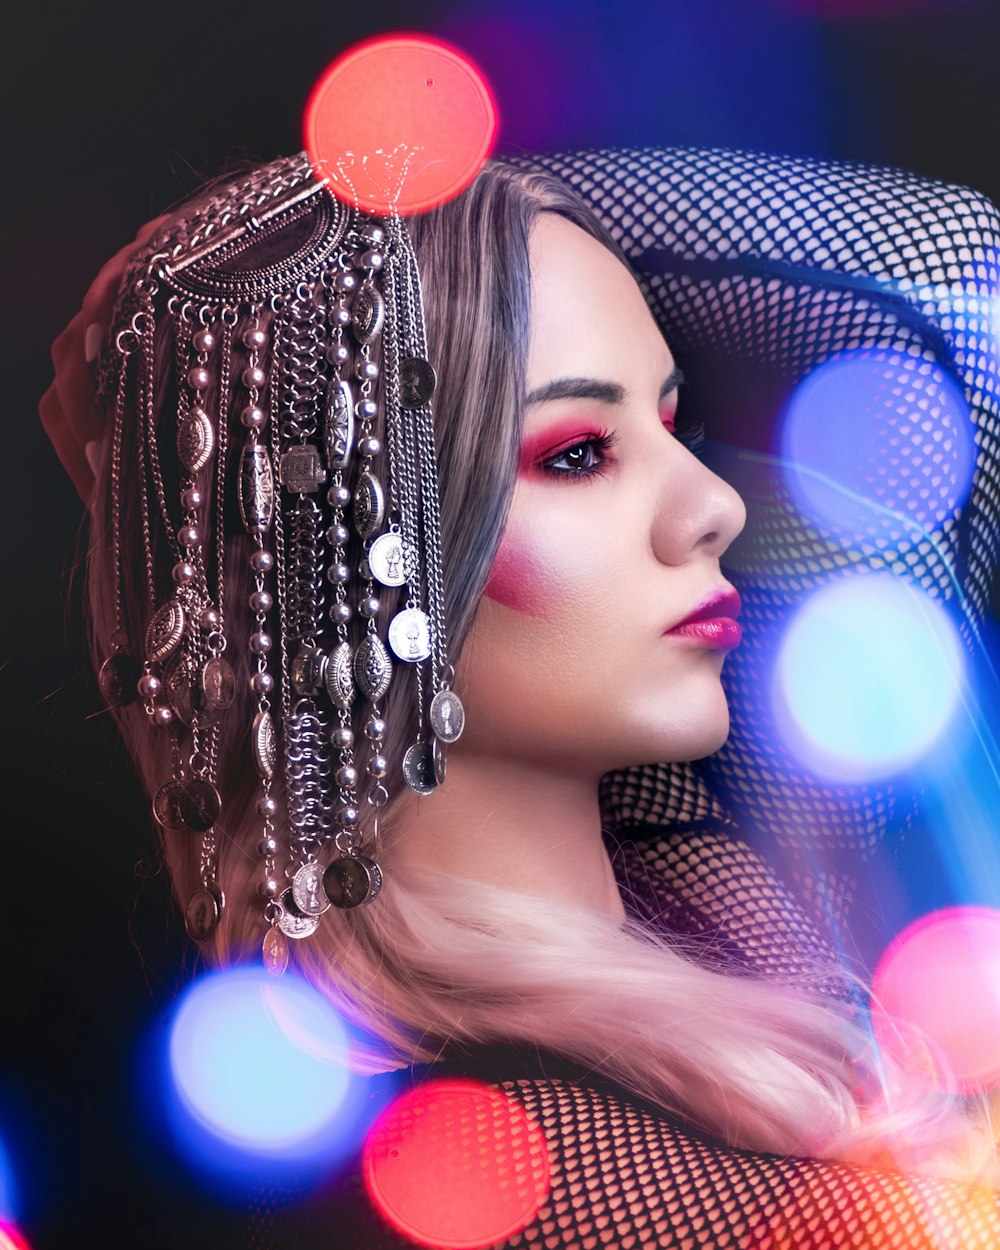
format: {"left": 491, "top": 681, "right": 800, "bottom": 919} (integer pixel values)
{"left": 459, "top": 214, "right": 745, "bottom": 775}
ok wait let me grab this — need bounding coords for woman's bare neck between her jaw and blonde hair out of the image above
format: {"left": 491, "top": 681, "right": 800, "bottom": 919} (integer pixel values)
{"left": 393, "top": 749, "right": 625, "bottom": 918}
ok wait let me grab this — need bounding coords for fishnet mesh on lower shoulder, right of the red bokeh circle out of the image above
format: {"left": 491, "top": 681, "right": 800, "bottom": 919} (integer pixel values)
{"left": 500, "top": 1080, "right": 1000, "bottom": 1250}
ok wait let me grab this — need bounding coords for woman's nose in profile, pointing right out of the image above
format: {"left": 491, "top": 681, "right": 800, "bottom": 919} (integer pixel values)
{"left": 653, "top": 444, "right": 746, "bottom": 564}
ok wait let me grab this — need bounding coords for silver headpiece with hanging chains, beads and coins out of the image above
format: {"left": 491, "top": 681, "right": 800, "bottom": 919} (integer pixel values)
{"left": 93, "top": 154, "right": 464, "bottom": 973}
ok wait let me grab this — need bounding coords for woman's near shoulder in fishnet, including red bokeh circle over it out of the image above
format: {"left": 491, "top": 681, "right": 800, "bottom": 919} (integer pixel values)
{"left": 251, "top": 1046, "right": 1000, "bottom": 1250}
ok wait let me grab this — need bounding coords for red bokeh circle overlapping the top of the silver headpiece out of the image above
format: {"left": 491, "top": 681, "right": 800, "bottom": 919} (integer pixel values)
{"left": 304, "top": 34, "right": 496, "bottom": 215}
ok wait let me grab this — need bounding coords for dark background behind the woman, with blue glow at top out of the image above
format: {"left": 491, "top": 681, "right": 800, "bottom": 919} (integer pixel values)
{"left": 0, "top": 0, "right": 1000, "bottom": 1250}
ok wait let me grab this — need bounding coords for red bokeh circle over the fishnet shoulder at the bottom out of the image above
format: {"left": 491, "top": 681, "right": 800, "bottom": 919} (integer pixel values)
{"left": 363, "top": 1079, "right": 550, "bottom": 1250}
